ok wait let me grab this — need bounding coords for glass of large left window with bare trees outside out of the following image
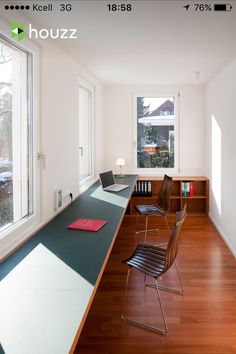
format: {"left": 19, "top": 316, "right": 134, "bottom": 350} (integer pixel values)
{"left": 0, "top": 41, "right": 13, "bottom": 228}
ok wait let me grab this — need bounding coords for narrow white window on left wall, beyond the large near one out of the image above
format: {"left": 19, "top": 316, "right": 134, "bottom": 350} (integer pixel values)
{"left": 79, "top": 79, "right": 94, "bottom": 183}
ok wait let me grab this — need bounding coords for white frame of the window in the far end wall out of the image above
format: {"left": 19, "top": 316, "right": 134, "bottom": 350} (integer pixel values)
{"left": 132, "top": 91, "right": 180, "bottom": 175}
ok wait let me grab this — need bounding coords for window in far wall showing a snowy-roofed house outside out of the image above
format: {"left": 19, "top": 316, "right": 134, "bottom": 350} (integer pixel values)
{"left": 134, "top": 95, "right": 178, "bottom": 172}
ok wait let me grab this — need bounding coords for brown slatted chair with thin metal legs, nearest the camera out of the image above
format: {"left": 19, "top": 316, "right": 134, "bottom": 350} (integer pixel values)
{"left": 121, "top": 205, "right": 187, "bottom": 334}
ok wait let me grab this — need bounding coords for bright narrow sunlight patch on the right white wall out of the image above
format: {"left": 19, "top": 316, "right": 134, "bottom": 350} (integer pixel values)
{"left": 211, "top": 115, "right": 221, "bottom": 215}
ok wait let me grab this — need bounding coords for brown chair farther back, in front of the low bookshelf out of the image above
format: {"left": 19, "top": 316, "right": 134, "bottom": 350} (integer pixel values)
{"left": 135, "top": 175, "right": 173, "bottom": 243}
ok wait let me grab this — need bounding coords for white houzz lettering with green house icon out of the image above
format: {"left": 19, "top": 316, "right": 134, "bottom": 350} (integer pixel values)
{"left": 11, "top": 22, "right": 77, "bottom": 41}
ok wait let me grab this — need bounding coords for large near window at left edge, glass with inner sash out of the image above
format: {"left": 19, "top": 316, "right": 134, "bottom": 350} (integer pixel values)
{"left": 0, "top": 37, "right": 32, "bottom": 231}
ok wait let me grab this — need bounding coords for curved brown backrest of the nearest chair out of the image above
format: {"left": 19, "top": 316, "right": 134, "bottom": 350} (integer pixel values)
{"left": 164, "top": 204, "right": 187, "bottom": 272}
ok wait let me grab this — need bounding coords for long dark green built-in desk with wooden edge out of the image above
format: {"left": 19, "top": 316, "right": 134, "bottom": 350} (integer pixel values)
{"left": 0, "top": 175, "right": 136, "bottom": 354}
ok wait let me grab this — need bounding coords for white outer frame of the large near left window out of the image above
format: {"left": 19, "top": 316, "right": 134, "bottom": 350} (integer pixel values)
{"left": 0, "top": 29, "right": 40, "bottom": 259}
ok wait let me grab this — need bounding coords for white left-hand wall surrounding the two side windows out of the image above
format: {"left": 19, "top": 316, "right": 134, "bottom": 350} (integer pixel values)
{"left": 0, "top": 16, "right": 103, "bottom": 259}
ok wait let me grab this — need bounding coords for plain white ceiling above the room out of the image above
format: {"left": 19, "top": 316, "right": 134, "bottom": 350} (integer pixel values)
{"left": 25, "top": 0, "right": 236, "bottom": 85}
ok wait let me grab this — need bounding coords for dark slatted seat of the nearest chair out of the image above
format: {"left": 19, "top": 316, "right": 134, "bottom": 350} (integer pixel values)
{"left": 123, "top": 243, "right": 167, "bottom": 278}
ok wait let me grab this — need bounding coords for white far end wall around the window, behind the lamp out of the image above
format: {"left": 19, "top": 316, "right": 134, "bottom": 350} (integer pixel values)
{"left": 104, "top": 85, "right": 205, "bottom": 175}
